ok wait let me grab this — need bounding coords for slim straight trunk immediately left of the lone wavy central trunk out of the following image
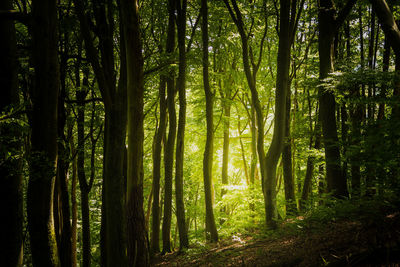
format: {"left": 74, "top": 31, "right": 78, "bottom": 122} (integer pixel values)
{"left": 175, "top": 0, "right": 189, "bottom": 249}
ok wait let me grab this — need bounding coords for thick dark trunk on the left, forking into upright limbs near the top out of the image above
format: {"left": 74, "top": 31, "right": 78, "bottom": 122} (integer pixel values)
{"left": 74, "top": 0, "right": 127, "bottom": 266}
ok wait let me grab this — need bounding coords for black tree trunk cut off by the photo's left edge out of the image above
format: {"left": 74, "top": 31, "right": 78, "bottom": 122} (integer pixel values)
{"left": 0, "top": 0, "right": 23, "bottom": 266}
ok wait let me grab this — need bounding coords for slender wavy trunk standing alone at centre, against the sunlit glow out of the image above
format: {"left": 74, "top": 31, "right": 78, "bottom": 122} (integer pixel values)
{"left": 201, "top": 0, "right": 218, "bottom": 242}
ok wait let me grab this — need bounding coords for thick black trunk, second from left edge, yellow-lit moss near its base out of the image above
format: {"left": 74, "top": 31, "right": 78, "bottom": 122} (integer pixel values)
{"left": 27, "top": 0, "right": 60, "bottom": 266}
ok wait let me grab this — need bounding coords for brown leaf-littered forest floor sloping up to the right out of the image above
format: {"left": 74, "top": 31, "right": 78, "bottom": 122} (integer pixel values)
{"left": 152, "top": 204, "right": 400, "bottom": 266}
